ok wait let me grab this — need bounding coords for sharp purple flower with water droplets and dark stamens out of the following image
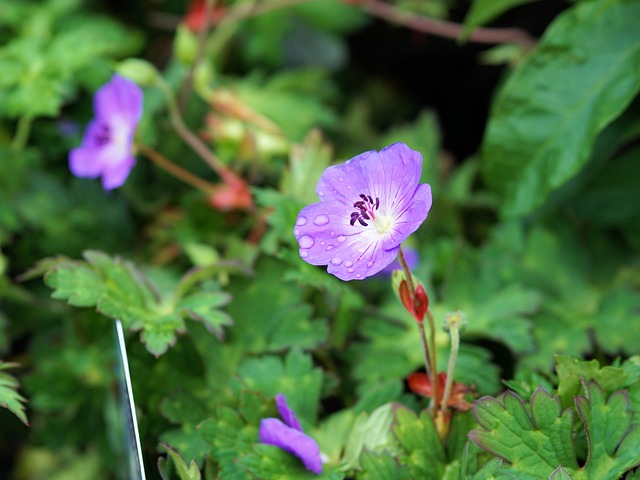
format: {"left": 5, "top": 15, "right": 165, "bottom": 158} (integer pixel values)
{"left": 293, "top": 143, "right": 431, "bottom": 280}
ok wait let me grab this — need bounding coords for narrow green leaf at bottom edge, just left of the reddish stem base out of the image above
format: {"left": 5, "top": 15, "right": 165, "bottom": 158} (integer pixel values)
{"left": 393, "top": 407, "right": 445, "bottom": 480}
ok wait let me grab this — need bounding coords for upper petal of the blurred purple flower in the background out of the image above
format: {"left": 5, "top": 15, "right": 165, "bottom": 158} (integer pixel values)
{"left": 93, "top": 75, "right": 143, "bottom": 129}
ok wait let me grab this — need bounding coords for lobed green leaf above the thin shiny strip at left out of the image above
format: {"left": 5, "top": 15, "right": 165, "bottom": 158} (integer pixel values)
{"left": 32, "top": 251, "right": 231, "bottom": 356}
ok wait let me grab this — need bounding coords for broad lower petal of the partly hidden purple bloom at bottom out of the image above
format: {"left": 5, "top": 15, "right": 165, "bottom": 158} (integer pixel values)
{"left": 258, "top": 418, "right": 322, "bottom": 475}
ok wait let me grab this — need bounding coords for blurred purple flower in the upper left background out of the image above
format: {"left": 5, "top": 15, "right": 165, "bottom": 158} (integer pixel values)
{"left": 69, "top": 75, "right": 142, "bottom": 190}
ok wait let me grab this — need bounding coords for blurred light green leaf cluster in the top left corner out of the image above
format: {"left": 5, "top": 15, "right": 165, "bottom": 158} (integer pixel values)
{"left": 0, "top": 1, "right": 140, "bottom": 118}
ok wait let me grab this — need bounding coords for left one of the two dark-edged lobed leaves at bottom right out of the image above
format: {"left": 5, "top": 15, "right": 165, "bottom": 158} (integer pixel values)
{"left": 469, "top": 388, "right": 578, "bottom": 476}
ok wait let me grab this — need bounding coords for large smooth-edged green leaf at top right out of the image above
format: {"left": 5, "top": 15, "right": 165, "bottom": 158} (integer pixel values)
{"left": 482, "top": 0, "right": 640, "bottom": 217}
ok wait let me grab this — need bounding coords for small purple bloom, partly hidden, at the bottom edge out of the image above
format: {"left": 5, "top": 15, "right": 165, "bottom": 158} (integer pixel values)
{"left": 258, "top": 394, "right": 322, "bottom": 475}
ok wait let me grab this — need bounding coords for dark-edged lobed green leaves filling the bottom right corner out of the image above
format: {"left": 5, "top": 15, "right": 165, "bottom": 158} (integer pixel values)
{"left": 469, "top": 383, "right": 640, "bottom": 479}
